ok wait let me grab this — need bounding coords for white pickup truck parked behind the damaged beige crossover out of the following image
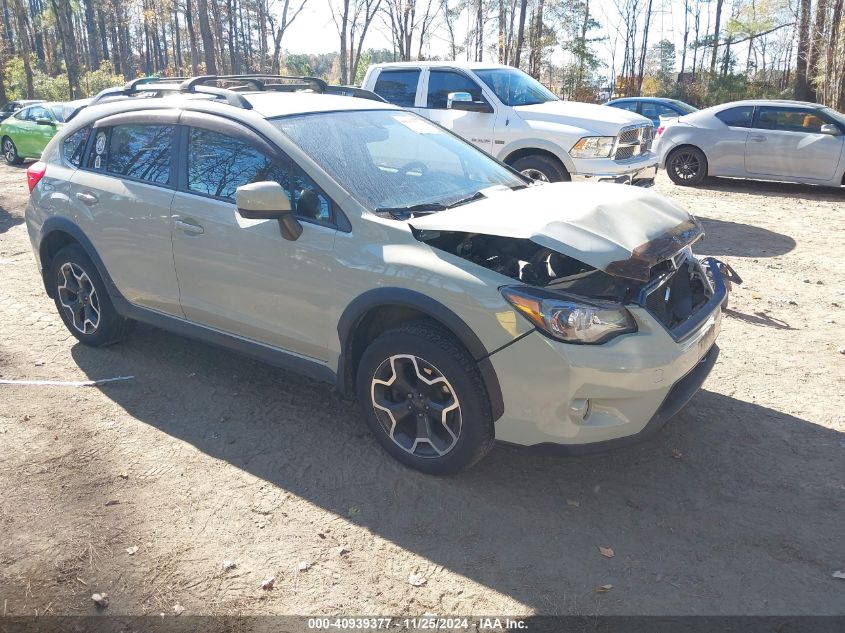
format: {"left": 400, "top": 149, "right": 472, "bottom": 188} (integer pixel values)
{"left": 362, "top": 61, "right": 657, "bottom": 186}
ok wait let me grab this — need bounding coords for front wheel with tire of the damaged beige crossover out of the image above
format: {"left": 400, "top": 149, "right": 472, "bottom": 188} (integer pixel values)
{"left": 356, "top": 321, "right": 495, "bottom": 475}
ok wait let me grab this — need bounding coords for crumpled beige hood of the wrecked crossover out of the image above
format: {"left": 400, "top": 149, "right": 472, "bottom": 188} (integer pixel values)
{"left": 408, "top": 182, "right": 704, "bottom": 281}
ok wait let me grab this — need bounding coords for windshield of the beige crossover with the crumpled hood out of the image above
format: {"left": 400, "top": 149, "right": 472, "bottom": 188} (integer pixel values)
{"left": 272, "top": 110, "right": 525, "bottom": 217}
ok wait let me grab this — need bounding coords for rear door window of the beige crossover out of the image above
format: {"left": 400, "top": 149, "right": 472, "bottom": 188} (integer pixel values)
{"left": 87, "top": 124, "right": 174, "bottom": 185}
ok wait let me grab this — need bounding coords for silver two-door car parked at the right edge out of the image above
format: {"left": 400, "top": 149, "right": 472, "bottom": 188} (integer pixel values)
{"left": 655, "top": 100, "right": 845, "bottom": 187}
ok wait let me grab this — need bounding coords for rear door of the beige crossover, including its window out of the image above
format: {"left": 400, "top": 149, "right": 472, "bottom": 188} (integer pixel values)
{"left": 68, "top": 111, "right": 181, "bottom": 316}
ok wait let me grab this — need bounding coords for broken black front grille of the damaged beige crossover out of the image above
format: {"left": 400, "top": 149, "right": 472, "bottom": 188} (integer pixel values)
{"left": 644, "top": 258, "right": 713, "bottom": 330}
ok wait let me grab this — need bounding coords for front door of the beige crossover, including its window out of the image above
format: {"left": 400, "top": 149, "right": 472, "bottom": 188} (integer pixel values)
{"left": 173, "top": 113, "right": 337, "bottom": 360}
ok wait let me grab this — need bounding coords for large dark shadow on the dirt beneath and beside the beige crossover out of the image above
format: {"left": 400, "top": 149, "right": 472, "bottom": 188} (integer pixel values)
{"left": 73, "top": 326, "right": 845, "bottom": 614}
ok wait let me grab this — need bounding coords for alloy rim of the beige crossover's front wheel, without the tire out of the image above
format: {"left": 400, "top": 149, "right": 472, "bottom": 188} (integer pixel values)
{"left": 370, "top": 354, "right": 462, "bottom": 458}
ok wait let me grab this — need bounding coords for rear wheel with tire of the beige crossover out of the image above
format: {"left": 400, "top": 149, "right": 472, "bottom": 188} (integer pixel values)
{"left": 49, "top": 244, "right": 134, "bottom": 347}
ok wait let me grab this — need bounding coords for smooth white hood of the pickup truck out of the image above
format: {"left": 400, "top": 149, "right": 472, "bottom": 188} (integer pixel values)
{"left": 514, "top": 101, "right": 652, "bottom": 136}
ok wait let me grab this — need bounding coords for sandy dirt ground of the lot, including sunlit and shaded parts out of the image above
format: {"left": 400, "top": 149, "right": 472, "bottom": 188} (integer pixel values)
{"left": 0, "top": 160, "right": 845, "bottom": 615}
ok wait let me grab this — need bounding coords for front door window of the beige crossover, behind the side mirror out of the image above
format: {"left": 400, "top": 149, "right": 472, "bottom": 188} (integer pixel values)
{"left": 188, "top": 128, "right": 333, "bottom": 224}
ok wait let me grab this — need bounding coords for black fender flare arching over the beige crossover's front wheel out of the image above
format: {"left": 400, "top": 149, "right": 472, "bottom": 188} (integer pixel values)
{"left": 337, "top": 288, "right": 505, "bottom": 421}
